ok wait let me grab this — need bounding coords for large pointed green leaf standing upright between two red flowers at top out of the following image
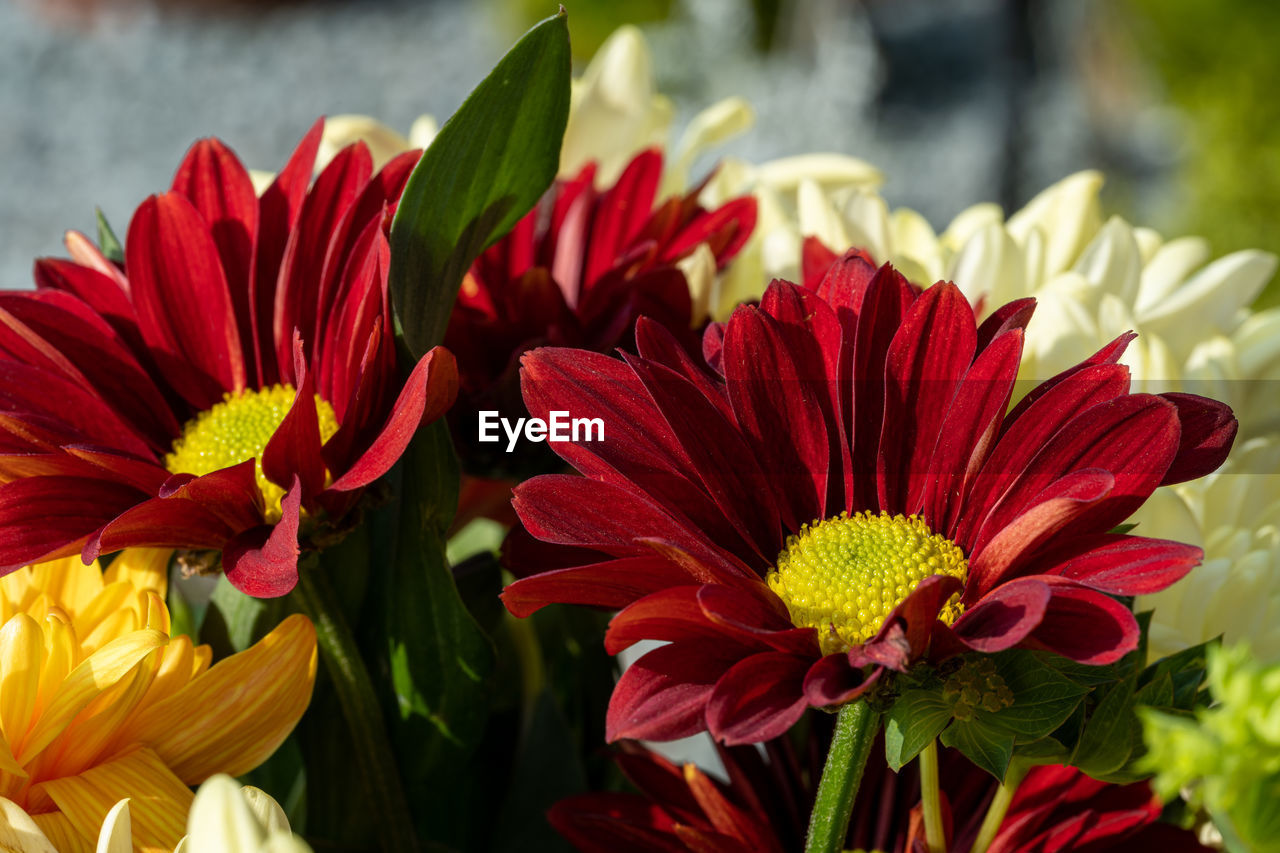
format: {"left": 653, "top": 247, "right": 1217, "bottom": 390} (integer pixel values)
{"left": 389, "top": 12, "right": 570, "bottom": 357}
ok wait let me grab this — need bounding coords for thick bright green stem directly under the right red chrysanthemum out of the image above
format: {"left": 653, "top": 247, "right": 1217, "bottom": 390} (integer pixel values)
{"left": 804, "top": 701, "right": 879, "bottom": 853}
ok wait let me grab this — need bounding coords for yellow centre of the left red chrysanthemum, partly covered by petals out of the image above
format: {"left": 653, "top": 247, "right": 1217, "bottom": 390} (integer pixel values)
{"left": 164, "top": 386, "right": 338, "bottom": 521}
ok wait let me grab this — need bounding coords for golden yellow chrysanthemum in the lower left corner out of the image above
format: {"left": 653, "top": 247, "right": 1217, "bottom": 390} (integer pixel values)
{"left": 0, "top": 549, "right": 316, "bottom": 853}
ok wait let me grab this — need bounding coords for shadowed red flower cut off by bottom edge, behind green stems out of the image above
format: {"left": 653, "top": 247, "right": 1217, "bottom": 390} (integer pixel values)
{"left": 547, "top": 738, "right": 1210, "bottom": 853}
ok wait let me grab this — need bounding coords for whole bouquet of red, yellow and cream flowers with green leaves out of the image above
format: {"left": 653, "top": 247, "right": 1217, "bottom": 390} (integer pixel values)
{"left": 0, "top": 12, "right": 1280, "bottom": 853}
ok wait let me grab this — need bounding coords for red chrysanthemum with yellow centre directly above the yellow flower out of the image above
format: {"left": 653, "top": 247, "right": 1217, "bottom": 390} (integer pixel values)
{"left": 0, "top": 122, "right": 457, "bottom": 596}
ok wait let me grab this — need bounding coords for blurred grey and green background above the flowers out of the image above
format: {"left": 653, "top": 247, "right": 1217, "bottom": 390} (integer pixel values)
{"left": 0, "top": 0, "right": 1280, "bottom": 304}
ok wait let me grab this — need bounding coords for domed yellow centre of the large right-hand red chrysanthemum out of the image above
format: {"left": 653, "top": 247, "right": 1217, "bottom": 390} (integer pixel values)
{"left": 765, "top": 512, "right": 969, "bottom": 654}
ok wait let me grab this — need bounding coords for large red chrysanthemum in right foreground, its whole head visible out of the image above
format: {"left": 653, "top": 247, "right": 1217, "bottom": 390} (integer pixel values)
{"left": 503, "top": 254, "right": 1235, "bottom": 743}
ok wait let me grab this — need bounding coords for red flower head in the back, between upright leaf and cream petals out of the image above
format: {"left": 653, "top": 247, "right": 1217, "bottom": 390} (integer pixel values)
{"left": 444, "top": 150, "right": 755, "bottom": 475}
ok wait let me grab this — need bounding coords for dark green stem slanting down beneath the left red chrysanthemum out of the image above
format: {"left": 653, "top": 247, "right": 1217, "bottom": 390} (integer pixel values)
{"left": 293, "top": 562, "right": 419, "bottom": 853}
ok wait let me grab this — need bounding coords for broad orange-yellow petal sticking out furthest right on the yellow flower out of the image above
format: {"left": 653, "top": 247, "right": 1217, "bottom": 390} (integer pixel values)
{"left": 121, "top": 613, "right": 316, "bottom": 785}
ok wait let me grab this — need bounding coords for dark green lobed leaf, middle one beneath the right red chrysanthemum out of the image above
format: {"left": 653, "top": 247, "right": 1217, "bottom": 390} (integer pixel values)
{"left": 974, "top": 649, "right": 1089, "bottom": 743}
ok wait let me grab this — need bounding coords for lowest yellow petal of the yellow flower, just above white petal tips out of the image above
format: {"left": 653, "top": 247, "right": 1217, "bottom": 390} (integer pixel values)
{"left": 41, "top": 749, "right": 192, "bottom": 853}
